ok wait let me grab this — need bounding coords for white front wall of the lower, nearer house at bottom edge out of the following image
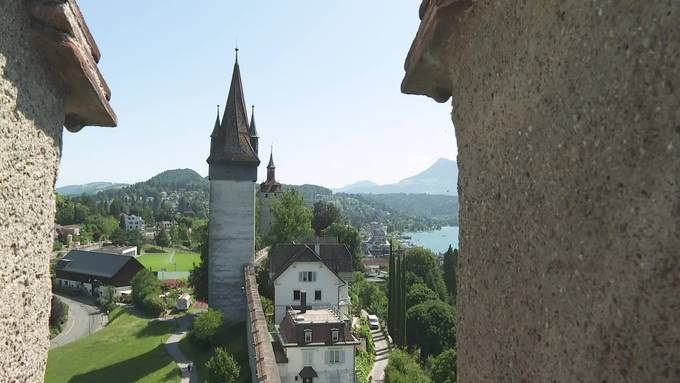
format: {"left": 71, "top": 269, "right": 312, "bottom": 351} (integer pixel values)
{"left": 277, "top": 345, "right": 355, "bottom": 383}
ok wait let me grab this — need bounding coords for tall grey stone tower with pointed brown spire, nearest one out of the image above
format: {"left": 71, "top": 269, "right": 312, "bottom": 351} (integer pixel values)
{"left": 207, "top": 49, "right": 260, "bottom": 323}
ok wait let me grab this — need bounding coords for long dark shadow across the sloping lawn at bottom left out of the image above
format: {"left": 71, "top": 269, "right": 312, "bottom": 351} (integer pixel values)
{"left": 69, "top": 345, "right": 179, "bottom": 383}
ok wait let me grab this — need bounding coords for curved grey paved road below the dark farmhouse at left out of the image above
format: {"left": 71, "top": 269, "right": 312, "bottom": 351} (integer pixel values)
{"left": 50, "top": 294, "right": 107, "bottom": 348}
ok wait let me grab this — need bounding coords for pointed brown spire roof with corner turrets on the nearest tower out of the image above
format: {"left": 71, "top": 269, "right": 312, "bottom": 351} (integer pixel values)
{"left": 208, "top": 49, "right": 260, "bottom": 166}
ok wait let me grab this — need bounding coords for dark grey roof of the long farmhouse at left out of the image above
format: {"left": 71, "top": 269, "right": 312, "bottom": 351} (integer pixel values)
{"left": 55, "top": 250, "right": 141, "bottom": 278}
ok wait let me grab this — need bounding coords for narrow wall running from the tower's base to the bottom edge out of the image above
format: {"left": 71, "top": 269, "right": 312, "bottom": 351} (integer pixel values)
{"left": 243, "top": 265, "right": 281, "bottom": 383}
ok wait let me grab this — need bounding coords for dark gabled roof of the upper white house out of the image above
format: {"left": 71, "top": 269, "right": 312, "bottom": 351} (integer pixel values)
{"left": 269, "top": 243, "right": 354, "bottom": 280}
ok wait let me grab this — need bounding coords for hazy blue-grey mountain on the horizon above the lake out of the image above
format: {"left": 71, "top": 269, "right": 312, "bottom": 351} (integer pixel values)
{"left": 334, "top": 158, "right": 458, "bottom": 195}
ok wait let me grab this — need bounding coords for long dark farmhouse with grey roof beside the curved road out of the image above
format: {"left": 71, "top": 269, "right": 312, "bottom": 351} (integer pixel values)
{"left": 54, "top": 250, "right": 144, "bottom": 296}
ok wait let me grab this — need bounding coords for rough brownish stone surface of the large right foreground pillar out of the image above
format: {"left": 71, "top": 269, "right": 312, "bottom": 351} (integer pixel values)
{"left": 404, "top": 0, "right": 680, "bottom": 382}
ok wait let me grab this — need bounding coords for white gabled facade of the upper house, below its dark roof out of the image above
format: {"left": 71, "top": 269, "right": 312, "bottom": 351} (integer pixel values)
{"left": 274, "top": 262, "right": 348, "bottom": 324}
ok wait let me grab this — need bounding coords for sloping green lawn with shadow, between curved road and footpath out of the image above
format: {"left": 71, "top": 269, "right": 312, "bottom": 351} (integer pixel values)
{"left": 45, "top": 308, "right": 180, "bottom": 383}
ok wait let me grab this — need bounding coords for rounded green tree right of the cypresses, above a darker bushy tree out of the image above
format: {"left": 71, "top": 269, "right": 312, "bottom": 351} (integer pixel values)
{"left": 404, "top": 247, "right": 447, "bottom": 300}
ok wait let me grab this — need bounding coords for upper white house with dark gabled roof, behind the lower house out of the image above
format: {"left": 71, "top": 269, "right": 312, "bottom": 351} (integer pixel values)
{"left": 269, "top": 243, "right": 354, "bottom": 323}
